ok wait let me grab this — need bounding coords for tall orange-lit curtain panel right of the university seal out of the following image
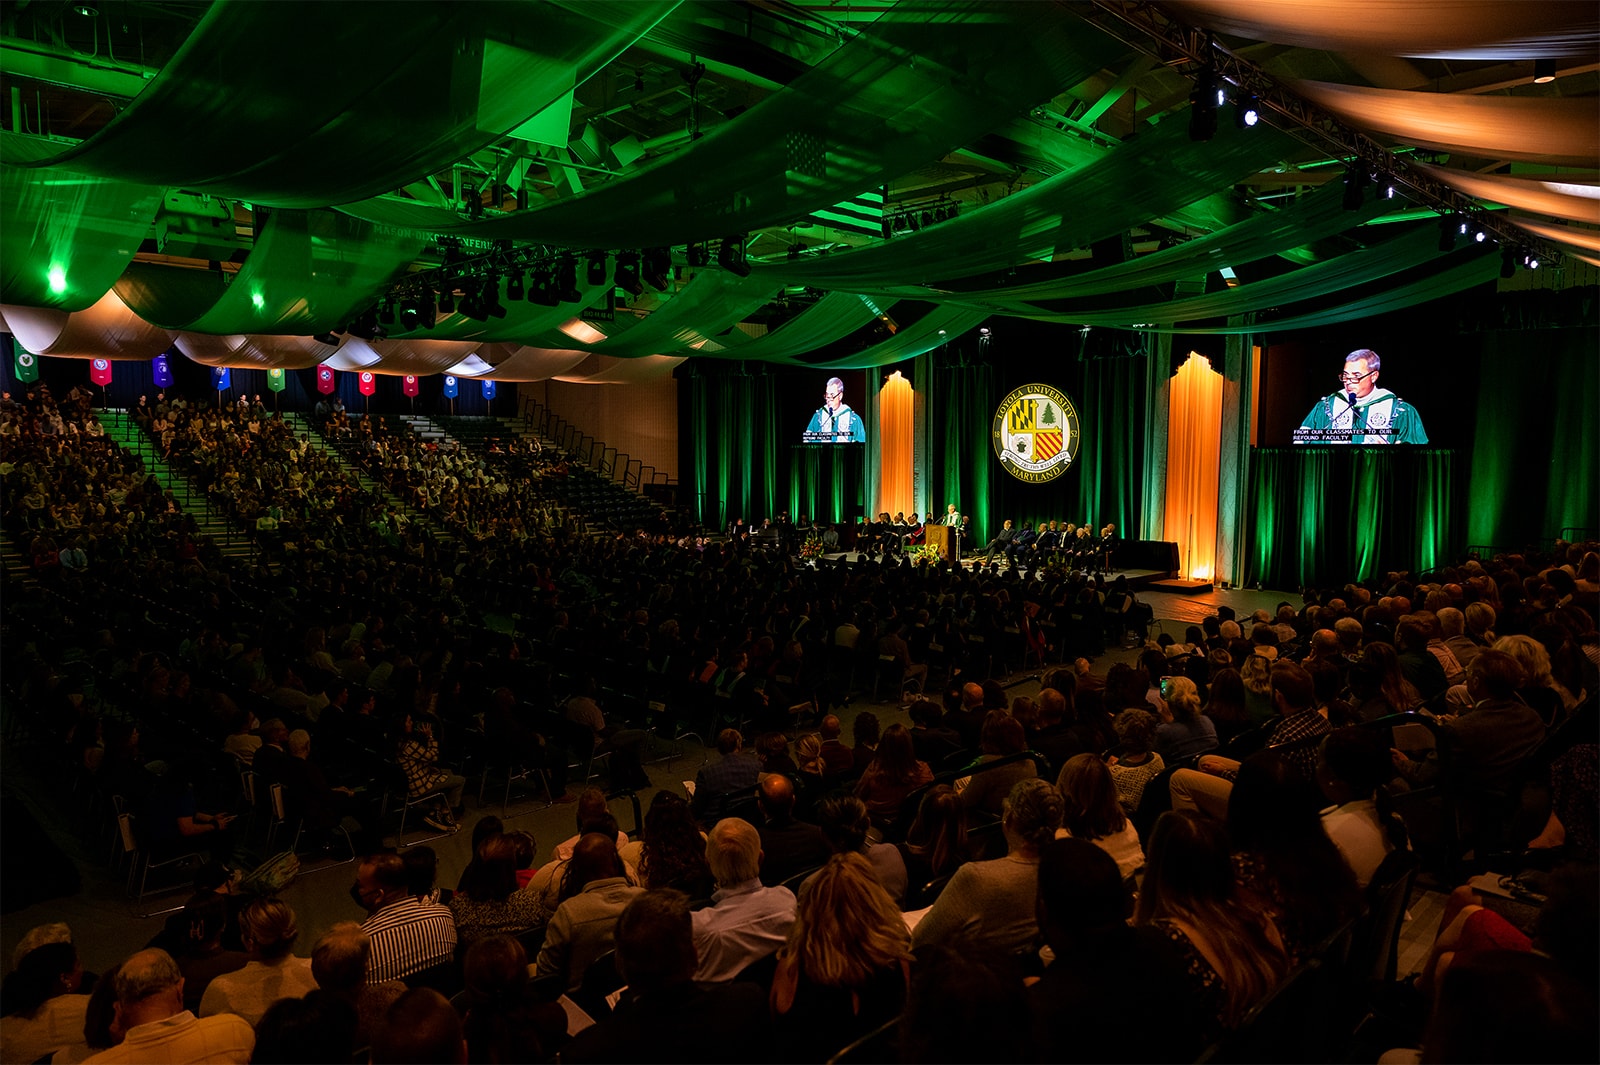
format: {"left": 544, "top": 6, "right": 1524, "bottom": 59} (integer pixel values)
{"left": 1163, "top": 352, "right": 1222, "bottom": 580}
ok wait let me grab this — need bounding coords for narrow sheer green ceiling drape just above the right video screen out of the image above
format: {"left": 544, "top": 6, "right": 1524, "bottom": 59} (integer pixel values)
{"left": 1026, "top": 225, "right": 1448, "bottom": 329}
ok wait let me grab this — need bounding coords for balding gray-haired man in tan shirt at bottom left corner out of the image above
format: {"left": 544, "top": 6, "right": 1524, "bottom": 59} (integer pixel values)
{"left": 85, "top": 950, "right": 256, "bottom": 1065}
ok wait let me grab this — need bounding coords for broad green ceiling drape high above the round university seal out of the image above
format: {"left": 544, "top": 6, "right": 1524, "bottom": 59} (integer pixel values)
{"left": 754, "top": 122, "right": 1290, "bottom": 292}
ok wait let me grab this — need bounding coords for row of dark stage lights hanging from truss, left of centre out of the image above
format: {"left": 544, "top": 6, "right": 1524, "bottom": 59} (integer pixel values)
{"left": 314, "top": 235, "right": 750, "bottom": 347}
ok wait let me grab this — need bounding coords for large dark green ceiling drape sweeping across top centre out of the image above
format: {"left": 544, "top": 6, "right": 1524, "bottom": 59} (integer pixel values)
{"left": 341, "top": 0, "right": 1128, "bottom": 248}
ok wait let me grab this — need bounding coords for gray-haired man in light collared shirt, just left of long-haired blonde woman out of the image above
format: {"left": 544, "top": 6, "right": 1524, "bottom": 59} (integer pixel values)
{"left": 693, "top": 817, "right": 795, "bottom": 982}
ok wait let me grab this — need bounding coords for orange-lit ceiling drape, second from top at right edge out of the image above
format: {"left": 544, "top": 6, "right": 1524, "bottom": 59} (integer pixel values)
{"left": 1290, "top": 79, "right": 1600, "bottom": 166}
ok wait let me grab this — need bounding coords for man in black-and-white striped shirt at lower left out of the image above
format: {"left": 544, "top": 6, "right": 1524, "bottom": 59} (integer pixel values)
{"left": 350, "top": 848, "right": 456, "bottom": 983}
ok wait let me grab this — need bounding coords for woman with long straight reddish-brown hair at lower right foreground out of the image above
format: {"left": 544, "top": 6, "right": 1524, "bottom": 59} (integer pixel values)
{"left": 1134, "top": 811, "right": 1288, "bottom": 1041}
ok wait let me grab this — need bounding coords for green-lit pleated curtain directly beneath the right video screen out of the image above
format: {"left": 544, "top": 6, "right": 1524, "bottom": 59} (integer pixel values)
{"left": 1245, "top": 448, "right": 1466, "bottom": 590}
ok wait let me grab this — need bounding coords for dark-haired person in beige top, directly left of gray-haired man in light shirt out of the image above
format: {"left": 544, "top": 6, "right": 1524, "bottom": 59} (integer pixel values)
{"left": 534, "top": 832, "right": 643, "bottom": 990}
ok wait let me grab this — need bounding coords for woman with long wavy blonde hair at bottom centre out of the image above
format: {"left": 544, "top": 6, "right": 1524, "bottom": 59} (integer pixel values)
{"left": 770, "top": 852, "right": 912, "bottom": 1062}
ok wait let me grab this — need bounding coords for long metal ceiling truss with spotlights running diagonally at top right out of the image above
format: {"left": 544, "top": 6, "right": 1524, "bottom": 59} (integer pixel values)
{"left": 1085, "top": 0, "right": 1562, "bottom": 262}
